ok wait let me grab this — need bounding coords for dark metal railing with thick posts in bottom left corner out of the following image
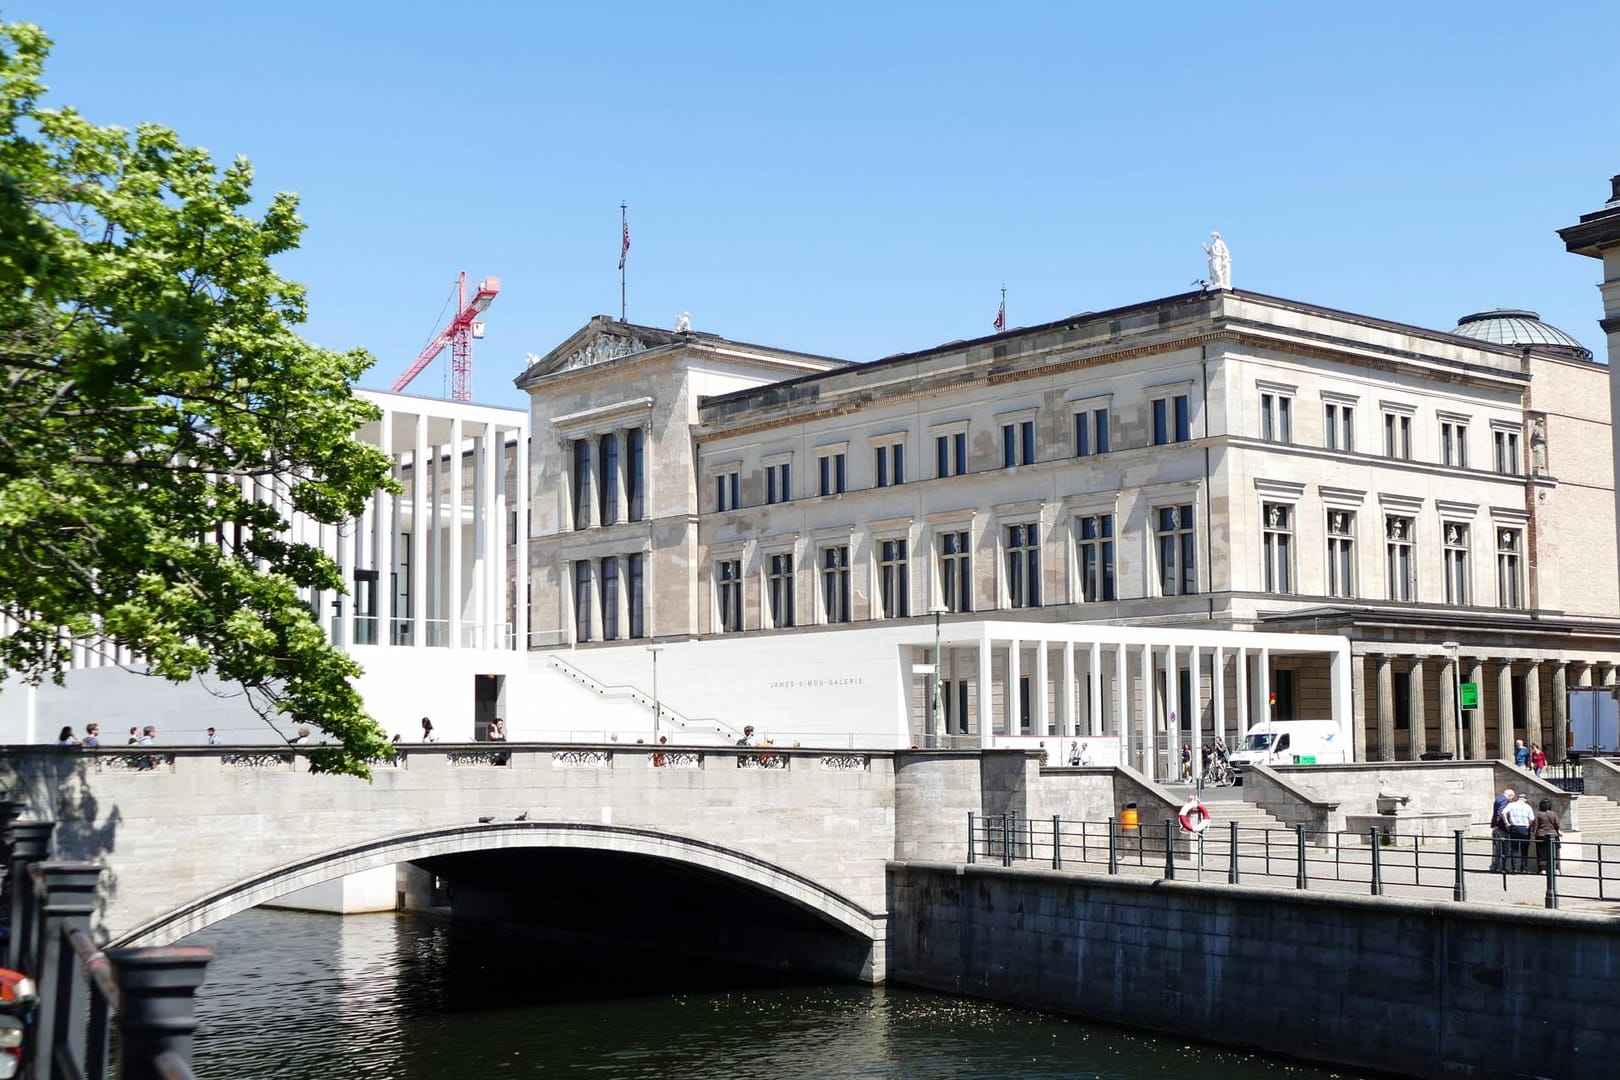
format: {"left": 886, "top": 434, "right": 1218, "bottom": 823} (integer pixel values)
{"left": 0, "top": 801, "right": 212, "bottom": 1080}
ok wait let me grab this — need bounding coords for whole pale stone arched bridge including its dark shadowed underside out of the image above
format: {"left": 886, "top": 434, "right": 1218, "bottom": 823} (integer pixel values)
{"left": 0, "top": 743, "right": 1038, "bottom": 980}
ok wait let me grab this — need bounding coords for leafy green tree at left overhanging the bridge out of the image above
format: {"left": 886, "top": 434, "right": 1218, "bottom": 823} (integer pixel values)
{"left": 0, "top": 24, "right": 397, "bottom": 776}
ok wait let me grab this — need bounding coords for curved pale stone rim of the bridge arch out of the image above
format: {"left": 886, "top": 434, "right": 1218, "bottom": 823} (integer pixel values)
{"left": 112, "top": 821, "right": 886, "bottom": 950}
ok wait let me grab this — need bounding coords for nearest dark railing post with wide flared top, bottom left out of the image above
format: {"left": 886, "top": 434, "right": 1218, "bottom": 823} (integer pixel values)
{"left": 107, "top": 946, "right": 214, "bottom": 1080}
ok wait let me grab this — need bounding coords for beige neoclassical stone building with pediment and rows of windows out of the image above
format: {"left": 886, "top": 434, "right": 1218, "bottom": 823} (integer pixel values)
{"left": 518, "top": 290, "right": 1620, "bottom": 772}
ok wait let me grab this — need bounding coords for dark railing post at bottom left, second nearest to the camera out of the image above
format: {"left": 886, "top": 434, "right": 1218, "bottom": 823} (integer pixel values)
{"left": 29, "top": 863, "right": 104, "bottom": 1062}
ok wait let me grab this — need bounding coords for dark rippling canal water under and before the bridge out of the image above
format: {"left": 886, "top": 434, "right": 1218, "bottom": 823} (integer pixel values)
{"left": 185, "top": 908, "right": 1354, "bottom": 1080}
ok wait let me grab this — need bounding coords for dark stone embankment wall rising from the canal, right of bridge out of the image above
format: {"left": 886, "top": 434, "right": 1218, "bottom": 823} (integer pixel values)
{"left": 888, "top": 863, "right": 1620, "bottom": 1080}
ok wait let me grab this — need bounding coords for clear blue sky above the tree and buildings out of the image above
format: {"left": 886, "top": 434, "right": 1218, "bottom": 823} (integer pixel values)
{"left": 12, "top": 0, "right": 1620, "bottom": 405}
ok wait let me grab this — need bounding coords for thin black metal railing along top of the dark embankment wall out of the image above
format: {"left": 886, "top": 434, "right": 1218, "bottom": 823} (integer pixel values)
{"left": 967, "top": 814, "right": 1620, "bottom": 908}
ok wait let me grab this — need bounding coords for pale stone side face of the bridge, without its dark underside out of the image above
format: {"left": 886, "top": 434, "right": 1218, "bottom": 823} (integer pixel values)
{"left": 0, "top": 743, "right": 896, "bottom": 944}
